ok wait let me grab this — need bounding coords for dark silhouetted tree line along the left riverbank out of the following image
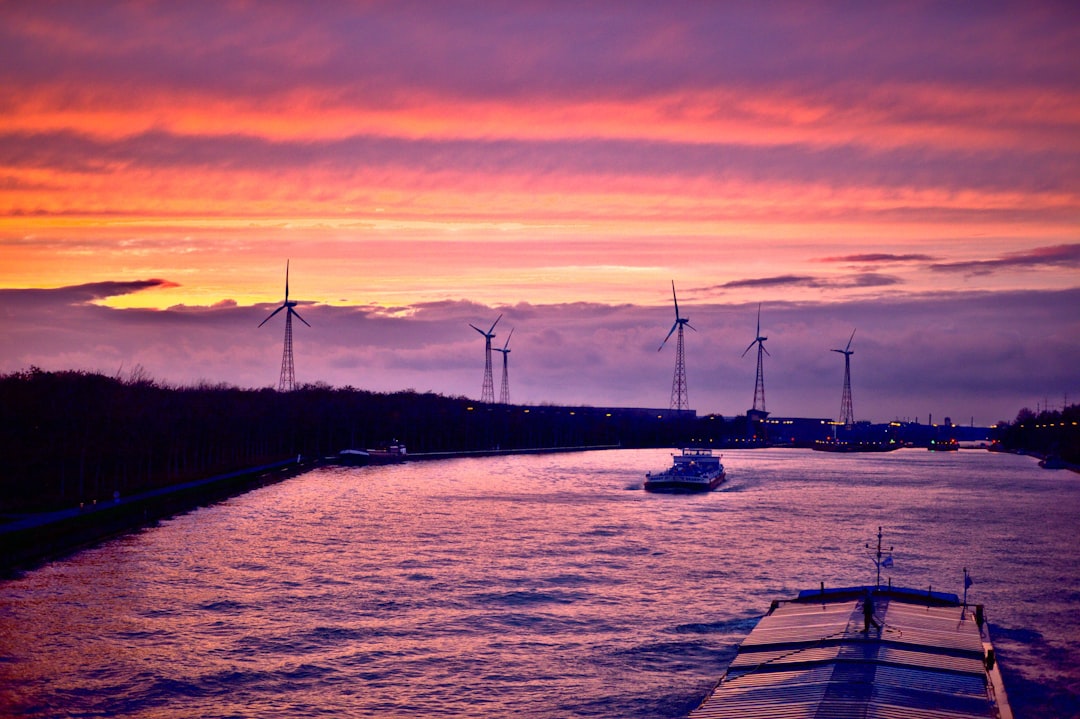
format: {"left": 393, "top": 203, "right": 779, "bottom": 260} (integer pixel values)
{"left": 0, "top": 368, "right": 732, "bottom": 514}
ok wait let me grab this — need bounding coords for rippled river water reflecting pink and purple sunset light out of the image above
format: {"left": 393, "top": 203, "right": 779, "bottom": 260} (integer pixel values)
{"left": 0, "top": 449, "right": 1080, "bottom": 719}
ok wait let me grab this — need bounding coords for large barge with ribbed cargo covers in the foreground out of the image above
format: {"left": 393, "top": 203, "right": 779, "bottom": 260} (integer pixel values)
{"left": 689, "top": 530, "right": 1013, "bottom": 719}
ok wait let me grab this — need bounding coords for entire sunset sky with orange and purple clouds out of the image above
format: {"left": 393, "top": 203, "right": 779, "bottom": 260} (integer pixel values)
{"left": 0, "top": 0, "right": 1080, "bottom": 424}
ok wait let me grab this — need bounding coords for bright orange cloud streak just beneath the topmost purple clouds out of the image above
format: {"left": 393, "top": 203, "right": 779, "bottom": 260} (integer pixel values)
{"left": 0, "top": 84, "right": 1080, "bottom": 150}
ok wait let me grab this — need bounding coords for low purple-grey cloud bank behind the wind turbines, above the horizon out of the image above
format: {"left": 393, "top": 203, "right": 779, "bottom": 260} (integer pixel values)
{"left": 0, "top": 281, "right": 1080, "bottom": 423}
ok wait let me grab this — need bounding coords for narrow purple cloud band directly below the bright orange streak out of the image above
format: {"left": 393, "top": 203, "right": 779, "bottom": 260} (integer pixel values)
{"left": 0, "top": 131, "right": 1077, "bottom": 196}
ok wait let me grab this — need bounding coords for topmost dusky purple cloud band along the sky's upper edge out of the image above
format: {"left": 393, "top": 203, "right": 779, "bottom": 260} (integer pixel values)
{"left": 0, "top": 2, "right": 1080, "bottom": 100}
